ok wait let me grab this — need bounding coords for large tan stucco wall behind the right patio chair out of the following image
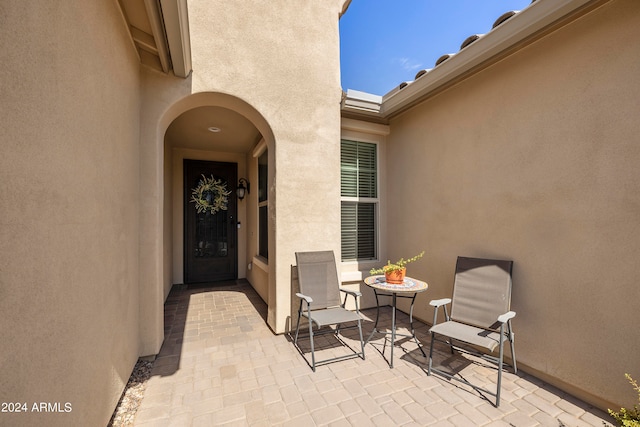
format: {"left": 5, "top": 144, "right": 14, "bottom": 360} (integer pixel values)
{"left": 386, "top": 0, "right": 640, "bottom": 408}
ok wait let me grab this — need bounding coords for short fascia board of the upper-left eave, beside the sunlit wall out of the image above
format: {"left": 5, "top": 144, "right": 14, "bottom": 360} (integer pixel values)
{"left": 160, "top": 0, "right": 191, "bottom": 77}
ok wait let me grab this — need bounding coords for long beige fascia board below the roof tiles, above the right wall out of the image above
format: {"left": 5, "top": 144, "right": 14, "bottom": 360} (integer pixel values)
{"left": 381, "top": 0, "right": 594, "bottom": 118}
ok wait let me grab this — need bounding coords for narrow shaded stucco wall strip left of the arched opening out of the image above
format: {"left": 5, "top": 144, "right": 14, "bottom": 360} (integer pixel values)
{"left": 138, "top": 68, "right": 191, "bottom": 356}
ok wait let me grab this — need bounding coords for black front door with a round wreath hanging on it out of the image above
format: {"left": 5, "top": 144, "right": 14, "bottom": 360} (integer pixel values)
{"left": 184, "top": 160, "right": 238, "bottom": 283}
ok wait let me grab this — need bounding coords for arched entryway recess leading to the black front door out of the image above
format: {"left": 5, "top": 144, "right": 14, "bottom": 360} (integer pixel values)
{"left": 162, "top": 93, "right": 274, "bottom": 303}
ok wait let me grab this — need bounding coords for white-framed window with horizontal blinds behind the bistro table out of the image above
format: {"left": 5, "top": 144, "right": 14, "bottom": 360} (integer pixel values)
{"left": 340, "top": 140, "right": 378, "bottom": 261}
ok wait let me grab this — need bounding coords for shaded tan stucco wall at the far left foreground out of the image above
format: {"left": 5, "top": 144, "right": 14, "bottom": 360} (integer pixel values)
{"left": 0, "top": 0, "right": 140, "bottom": 426}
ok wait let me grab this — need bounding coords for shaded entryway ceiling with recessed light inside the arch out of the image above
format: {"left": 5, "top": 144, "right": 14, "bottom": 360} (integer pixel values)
{"left": 165, "top": 106, "right": 261, "bottom": 153}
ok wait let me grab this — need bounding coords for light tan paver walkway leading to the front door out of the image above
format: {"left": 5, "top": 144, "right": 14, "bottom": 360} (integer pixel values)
{"left": 135, "top": 280, "right": 610, "bottom": 427}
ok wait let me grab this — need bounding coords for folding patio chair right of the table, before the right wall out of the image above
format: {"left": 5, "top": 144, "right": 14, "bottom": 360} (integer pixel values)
{"left": 428, "top": 257, "right": 518, "bottom": 407}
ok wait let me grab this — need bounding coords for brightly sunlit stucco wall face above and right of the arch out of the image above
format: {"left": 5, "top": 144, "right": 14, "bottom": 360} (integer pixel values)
{"left": 184, "top": 0, "right": 344, "bottom": 332}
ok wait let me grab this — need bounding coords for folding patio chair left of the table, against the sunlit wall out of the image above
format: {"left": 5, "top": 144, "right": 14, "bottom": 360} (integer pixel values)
{"left": 294, "top": 251, "right": 364, "bottom": 372}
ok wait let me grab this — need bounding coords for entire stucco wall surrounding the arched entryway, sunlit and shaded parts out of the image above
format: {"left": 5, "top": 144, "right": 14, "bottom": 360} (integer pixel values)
{"left": 135, "top": 0, "right": 344, "bottom": 355}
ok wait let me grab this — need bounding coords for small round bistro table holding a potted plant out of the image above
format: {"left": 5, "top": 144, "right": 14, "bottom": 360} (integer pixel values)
{"left": 364, "top": 275, "right": 429, "bottom": 368}
